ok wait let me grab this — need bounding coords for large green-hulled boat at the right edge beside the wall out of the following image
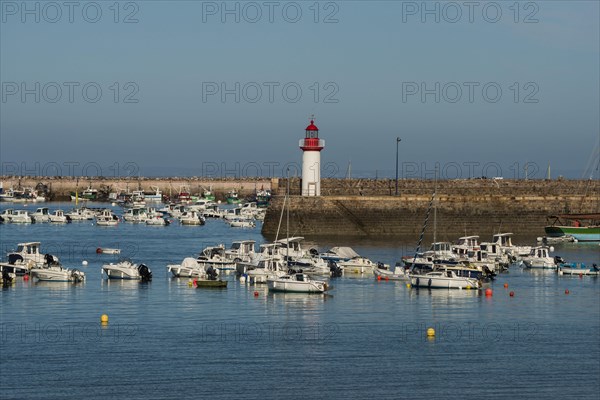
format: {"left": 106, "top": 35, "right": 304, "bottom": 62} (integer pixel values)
{"left": 544, "top": 214, "right": 600, "bottom": 242}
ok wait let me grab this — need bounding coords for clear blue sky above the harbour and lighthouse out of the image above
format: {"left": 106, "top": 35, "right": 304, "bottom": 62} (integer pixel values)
{"left": 0, "top": 0, "right": 600, "bottom": 178}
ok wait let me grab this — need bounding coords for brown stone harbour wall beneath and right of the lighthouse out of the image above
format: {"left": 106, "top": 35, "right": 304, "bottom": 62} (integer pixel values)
{"left": 262, "top": 179, "right": 600, "bottom": 240}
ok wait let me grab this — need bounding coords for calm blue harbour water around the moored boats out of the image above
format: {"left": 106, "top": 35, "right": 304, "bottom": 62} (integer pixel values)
{"left": 0, "top": 204, "right": 600, "bottom": 400}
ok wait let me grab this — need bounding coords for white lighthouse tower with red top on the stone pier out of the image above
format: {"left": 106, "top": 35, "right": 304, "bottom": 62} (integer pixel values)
{"left": 300, "top": 117, "right": 325, "bottom": 196}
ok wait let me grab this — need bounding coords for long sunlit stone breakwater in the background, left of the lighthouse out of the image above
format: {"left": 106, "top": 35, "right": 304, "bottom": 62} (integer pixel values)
{"left": 0, "top": 176, "right": 277, "bottom": 200}
